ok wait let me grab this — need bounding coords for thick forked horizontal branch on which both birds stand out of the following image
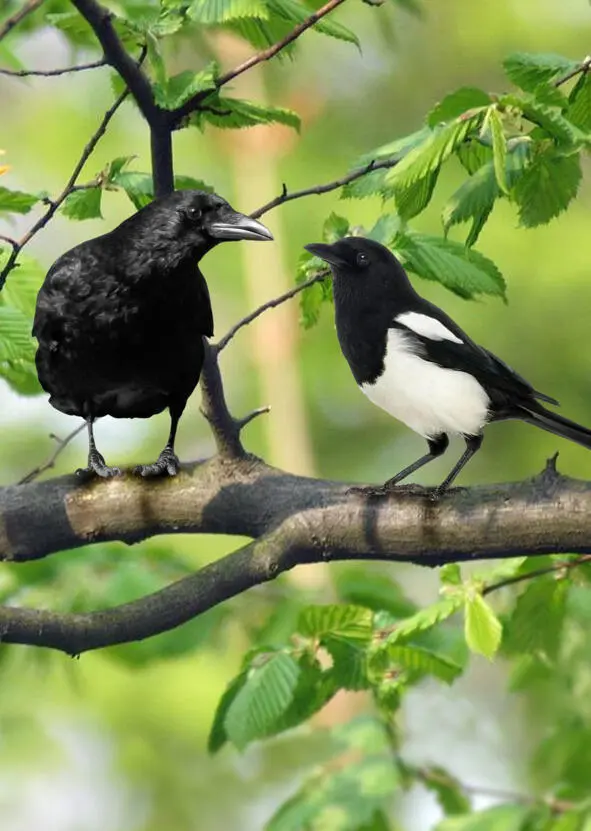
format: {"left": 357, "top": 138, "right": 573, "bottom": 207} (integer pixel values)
{"left": 0, "top": 457, "right": 591, "bottom": 654}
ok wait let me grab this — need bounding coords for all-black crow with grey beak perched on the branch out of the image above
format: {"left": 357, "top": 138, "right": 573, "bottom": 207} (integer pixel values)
{"left": 33, "top": 190, "right": 273, "bottom": 477}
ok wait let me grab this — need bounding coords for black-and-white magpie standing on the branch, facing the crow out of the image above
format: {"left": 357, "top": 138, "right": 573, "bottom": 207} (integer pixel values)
{"left": 305, "top": 237, "right": 591, "bottom": 496}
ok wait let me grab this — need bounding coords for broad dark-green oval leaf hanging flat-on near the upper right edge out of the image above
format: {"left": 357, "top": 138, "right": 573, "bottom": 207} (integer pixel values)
{"left": 511, "top": 148, "right": 582, "bottom": 228}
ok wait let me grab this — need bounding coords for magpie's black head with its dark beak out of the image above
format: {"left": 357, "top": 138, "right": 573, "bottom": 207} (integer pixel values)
{"left": 304, "top": 237, "right": 402, "bottom": 283}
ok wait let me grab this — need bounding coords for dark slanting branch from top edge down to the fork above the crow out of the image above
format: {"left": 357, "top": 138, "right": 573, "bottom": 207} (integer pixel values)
{"left": 72, "top": 0, "right": 160, "bottom": 123}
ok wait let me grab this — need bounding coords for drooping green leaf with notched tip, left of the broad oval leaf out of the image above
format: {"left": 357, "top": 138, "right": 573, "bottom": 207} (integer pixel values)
{"left": 441, "top": 162, "right": 499, "bottom": 247}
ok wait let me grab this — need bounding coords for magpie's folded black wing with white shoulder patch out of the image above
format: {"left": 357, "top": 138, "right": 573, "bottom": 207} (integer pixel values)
{"left": 392, "top": 301, "right": 558, "bottom": 414}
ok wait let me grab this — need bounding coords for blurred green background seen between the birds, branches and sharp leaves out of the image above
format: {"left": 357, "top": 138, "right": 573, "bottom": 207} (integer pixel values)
{"left": 0, "top": 0, "right": 591, "bottom": 831}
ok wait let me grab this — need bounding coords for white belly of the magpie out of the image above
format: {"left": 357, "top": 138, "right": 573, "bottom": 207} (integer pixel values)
{"left": 361, "top": 329, "right": 490, "bottom": 438}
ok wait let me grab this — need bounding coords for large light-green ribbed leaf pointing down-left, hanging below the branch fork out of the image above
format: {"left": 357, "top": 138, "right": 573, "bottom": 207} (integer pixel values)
{"left": 224, "top": 652, "right": 300, "bottom": 750}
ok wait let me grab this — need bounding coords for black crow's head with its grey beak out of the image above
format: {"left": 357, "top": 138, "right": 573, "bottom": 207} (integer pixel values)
{"left": 124, "top": 190, "right": 273, "bottom": 256}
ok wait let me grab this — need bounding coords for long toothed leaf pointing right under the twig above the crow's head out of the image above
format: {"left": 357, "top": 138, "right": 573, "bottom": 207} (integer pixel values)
{"left": 189, "top": 95, "right": 300, "bottom": 130}
